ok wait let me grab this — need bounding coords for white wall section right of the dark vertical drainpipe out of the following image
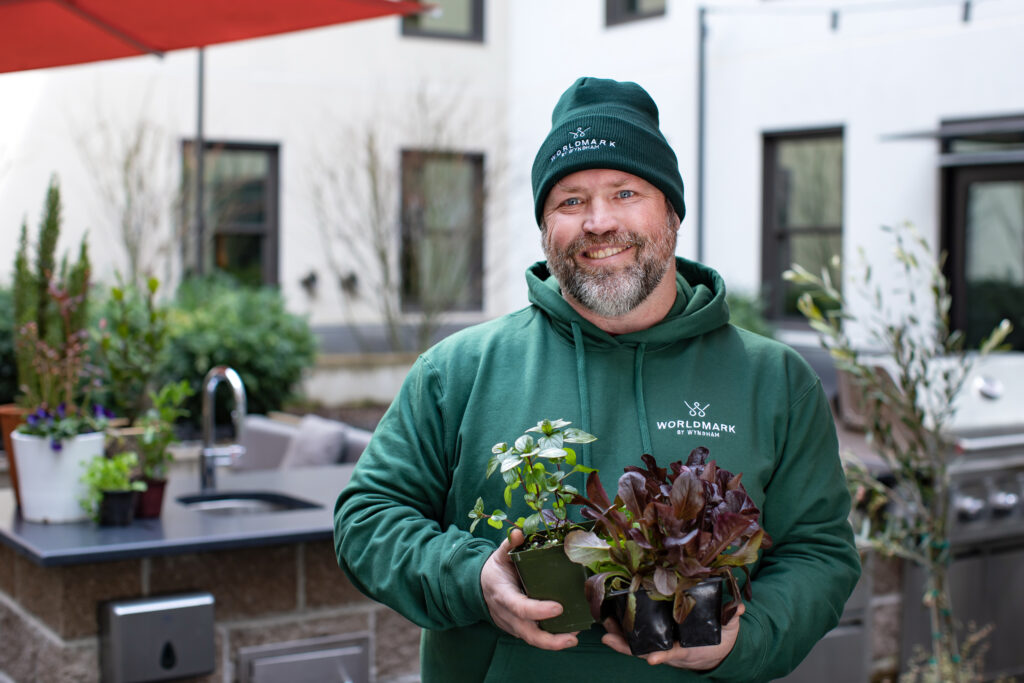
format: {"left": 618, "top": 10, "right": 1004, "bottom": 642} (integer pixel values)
{"left": 706, "top": 0, "right": 1024, "bottom": 311}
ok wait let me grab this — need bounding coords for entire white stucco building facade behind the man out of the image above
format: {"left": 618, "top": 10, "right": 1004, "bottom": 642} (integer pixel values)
{"left": 0, "top": 0, "right": 1024, "bottom": 395}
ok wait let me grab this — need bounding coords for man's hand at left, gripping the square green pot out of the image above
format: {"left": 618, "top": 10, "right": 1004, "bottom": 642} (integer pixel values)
{"left": 480, "top": 529, "right": 581, "bottom": 651}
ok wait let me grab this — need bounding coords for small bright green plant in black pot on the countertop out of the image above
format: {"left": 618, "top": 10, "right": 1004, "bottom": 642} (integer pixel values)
{"left": 79, "top": 452, "right": 145, "bottom": 526}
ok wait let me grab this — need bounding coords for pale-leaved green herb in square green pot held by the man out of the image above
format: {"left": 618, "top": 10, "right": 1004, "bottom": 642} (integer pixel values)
{"left": 469, "top": 420, "right": 596, "bottom": 633}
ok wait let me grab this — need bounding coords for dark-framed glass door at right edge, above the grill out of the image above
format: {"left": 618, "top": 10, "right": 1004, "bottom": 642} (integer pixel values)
{"left": 939, "top": 117, "right": 1024, "bottom": 350}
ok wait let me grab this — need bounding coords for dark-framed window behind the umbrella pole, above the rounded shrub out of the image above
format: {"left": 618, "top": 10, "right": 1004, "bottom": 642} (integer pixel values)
{"left": 182, "top": 140, "right": 280, "bottom": 286}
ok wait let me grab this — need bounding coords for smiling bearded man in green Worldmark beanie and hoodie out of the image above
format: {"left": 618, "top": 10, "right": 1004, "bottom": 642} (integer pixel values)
{"left": 335, "top": 78, "right": 860, "bottom": 683}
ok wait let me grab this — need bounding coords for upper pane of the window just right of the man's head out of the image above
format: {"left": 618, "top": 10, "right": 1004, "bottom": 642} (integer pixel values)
{"left": 775, "top": 137, "right": 843, "bottom": 229}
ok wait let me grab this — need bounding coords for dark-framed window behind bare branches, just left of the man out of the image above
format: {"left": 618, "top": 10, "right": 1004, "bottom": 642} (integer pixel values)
{"left": 399, "top": 150, "right": 483, "bottom": 313}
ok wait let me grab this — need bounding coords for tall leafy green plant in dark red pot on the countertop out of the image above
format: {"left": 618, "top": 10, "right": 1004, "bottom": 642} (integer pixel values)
{"left": 132, "top": 380, "right": 193, "bottom": 518}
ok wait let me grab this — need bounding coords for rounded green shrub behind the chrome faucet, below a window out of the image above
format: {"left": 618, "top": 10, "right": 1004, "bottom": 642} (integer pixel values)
{"left": 161, "top": 274, "right": 316, "bottom": 424}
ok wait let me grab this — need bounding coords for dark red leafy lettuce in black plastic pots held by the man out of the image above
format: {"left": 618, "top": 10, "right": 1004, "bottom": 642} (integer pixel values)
{"left": 565, "top": 447, "right": 771, "bottom": 654}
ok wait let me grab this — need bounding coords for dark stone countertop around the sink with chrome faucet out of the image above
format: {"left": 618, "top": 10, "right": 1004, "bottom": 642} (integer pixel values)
{"left": 0, "top": 465, "right": 353, "bottom": 566}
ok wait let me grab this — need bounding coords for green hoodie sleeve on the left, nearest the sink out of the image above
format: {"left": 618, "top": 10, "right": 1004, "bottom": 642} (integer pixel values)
{"left": 334, "top": 356, "right": 495, "bottom": 629}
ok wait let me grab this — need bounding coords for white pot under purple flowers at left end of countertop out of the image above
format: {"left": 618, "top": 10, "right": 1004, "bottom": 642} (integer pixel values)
{"left": 11, "top": 432, "right": 103, "bottom": 523}
